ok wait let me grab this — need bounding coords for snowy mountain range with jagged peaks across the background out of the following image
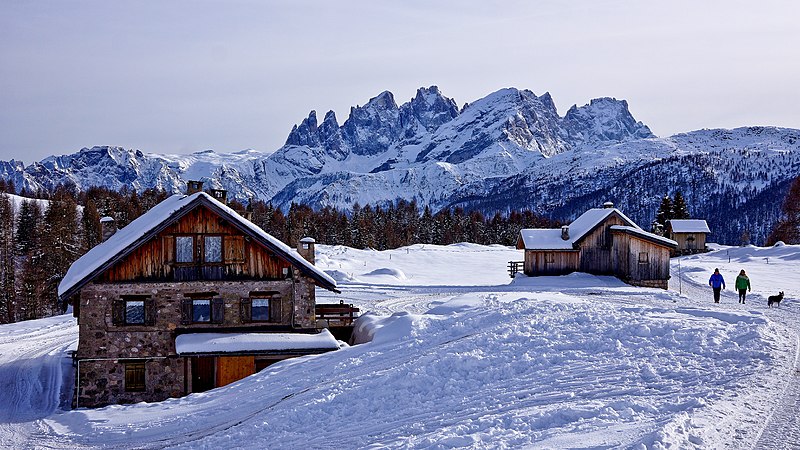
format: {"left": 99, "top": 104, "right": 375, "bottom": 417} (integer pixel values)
{"left": 0, "top": 86, "right": 800, "bottom": 243}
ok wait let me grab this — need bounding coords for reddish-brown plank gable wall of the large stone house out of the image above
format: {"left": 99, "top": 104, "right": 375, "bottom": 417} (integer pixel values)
{"left": 101, "top": 205, "right": 290, "bottom": 282}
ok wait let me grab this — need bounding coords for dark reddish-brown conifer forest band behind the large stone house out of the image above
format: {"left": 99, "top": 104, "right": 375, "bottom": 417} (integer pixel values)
{"left": 0, "top": 183, "right": 557, "bottom": 323}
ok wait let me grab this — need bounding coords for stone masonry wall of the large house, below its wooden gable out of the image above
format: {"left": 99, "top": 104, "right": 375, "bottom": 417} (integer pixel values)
{"left": 75, "top": 273, "right": 316, "bottom": 407}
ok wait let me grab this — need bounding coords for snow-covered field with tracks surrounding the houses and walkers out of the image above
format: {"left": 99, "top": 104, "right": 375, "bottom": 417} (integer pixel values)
{"left": 0, "top": 244, "right": 800, "bottom": 449}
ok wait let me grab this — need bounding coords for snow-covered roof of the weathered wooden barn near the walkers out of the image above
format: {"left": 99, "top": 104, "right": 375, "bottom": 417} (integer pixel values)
{"left": 520, "top": 208, "right": 639, "bottom": 250}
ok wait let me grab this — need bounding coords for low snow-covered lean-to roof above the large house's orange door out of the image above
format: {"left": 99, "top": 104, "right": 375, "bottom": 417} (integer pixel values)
{"left": 175, "top": 329, "right": 339, "bottom": 355}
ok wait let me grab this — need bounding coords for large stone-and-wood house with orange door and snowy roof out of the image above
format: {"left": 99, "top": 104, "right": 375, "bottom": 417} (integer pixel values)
{"left": 59, "top": 186, "right": 338, "bottom": 407}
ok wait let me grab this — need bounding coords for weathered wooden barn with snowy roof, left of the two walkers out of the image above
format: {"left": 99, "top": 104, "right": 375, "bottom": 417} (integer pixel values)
{"left": 517, "top": 203, "right": 677, "bottom": 289}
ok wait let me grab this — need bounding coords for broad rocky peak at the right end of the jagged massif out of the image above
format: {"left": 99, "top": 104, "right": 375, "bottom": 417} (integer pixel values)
{"left": 564, "top": 97, "right": 655, "bottom": 145}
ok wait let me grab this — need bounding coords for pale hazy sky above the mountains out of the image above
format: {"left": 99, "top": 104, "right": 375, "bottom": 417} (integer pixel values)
{"left": 0, "top": 0, "right": 800, "bottom": 164}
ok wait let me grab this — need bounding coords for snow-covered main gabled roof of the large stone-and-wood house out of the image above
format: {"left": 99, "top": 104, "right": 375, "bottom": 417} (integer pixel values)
{"left": 58, "top": 192, "right": 336, "bottom": 298}
